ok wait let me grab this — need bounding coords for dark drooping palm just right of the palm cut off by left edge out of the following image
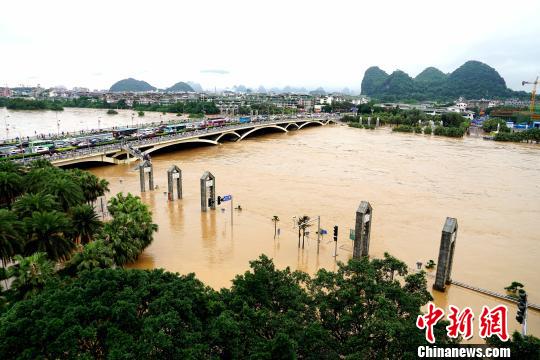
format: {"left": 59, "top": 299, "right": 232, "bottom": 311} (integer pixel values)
{"left": 24, "top": 211, "right": 75, "bottom": 261}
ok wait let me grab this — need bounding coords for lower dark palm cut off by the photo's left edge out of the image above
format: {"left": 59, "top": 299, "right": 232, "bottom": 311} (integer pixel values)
{"left": 0, "top": 209, "right": 23, "bottom": 266}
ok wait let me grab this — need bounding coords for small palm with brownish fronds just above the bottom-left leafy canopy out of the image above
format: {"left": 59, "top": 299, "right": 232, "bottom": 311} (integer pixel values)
{"left": 8, "top": 252, "right": 54, "bottom": 299}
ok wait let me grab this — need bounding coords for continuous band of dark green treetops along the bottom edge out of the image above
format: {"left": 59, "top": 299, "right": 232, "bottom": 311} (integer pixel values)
{"left": 0, "top": 255, "right": 468, "bottom": 359}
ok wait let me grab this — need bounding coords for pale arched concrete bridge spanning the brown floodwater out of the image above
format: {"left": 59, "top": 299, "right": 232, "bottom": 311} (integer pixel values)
{"left": 27, "top": 118, "right": 337, "bottom": 166}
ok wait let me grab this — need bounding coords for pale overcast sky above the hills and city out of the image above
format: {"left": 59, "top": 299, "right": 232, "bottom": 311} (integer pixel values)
{"left": 0, "top": 0, "right": 540, "bottom": 90}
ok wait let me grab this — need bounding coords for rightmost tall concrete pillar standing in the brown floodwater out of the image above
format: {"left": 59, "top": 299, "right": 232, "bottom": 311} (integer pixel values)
{"left": 433, "top": 217, "right": 458, "bottom": 292}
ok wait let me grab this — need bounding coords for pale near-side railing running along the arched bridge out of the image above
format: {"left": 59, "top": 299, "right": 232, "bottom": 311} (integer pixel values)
{"left": 13, "top": 118, "right": 329, "bottom": 163}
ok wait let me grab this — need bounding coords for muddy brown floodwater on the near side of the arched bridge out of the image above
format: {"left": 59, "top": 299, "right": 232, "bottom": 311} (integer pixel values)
{"left": 92, "top": 126, "right": 540, "bottom": 336}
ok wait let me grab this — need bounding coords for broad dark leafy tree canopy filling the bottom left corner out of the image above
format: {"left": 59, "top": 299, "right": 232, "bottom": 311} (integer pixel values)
{"left": 0, "top": 269, "right": 214, "bottom": 359}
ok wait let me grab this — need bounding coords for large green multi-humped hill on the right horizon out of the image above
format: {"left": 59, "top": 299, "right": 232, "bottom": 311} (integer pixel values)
{"left": 362, "top": 61, "right": 522, "bottom": 101}
